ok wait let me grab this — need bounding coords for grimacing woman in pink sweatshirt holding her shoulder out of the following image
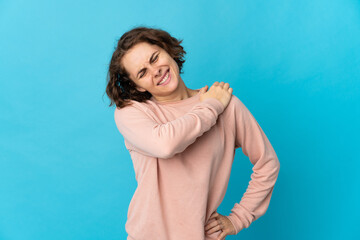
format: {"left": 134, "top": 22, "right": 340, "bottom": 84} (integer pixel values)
{"left": 106, "top": 27, "right": 280, "bottom": 240}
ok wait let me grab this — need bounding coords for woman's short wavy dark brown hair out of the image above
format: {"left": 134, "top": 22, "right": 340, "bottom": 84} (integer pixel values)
{"left": 106, "top": 26, "right": 186, "bottom": 108}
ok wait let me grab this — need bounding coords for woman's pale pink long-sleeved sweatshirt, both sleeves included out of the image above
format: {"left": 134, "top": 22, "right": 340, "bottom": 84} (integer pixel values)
{"left": 114, "top": 89, "right": 280, "bottom": 240}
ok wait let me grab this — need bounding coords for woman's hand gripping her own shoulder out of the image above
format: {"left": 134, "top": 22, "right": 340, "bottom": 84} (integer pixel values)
{"left": 200, "top": 82, "right": 233, "bottom": 108}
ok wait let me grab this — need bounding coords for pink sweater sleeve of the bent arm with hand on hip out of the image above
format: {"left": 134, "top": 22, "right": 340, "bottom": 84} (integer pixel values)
{"left": 228, "top": 96, "right": 280, "bottom": 234}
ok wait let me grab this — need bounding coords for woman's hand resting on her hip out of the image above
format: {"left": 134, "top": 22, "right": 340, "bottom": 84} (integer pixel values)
{"left": 205, "top": 211, "right": 236, "bottom": 240}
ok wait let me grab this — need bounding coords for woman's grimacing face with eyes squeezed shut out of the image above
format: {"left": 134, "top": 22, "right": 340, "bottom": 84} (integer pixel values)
{"left": 121, "top": 42, "right": 181, "bottom": 98}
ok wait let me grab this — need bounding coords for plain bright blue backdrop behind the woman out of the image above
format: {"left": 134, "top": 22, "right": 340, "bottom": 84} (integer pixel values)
{"left": 0, "top": 0, "right": 360, "bottom": 240}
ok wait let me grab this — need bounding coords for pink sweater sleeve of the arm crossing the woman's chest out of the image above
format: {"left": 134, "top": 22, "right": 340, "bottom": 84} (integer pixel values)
{"left": 114, "top": 98, "right": 225, "bottom": 158}
